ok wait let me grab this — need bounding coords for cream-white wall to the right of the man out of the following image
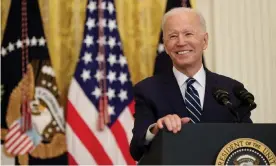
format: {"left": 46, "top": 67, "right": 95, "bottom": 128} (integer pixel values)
{"left": 196, "top": 0, "right": 276, "bottom": 123}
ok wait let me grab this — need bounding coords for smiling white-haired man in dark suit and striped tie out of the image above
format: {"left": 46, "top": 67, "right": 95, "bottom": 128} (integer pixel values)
{"left": 130, "top": 7, "right": 252, "bottom": 161}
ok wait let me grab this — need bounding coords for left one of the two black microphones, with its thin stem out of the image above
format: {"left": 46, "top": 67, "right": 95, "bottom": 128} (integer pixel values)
{"left": 213, "top": 88, "right": 240, "bottom": 123}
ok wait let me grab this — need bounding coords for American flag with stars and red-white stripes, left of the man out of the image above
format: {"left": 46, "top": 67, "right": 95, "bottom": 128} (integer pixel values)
{"left": 66, "top": 0, "right": 135, "bottom": 165}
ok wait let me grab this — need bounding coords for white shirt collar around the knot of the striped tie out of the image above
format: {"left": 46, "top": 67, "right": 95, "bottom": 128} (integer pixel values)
{"left": 173, "top": 65, "right": 206, "bottom": 88}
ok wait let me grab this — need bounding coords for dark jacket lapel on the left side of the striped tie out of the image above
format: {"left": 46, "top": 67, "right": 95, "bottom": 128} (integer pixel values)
{"left": 162, "top": 70, "right": 188, "bottom": 117}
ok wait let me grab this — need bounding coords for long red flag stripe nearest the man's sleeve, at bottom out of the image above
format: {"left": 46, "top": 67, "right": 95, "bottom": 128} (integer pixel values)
{"left": 111, "top": 121, "right": 135, "bottom": 165}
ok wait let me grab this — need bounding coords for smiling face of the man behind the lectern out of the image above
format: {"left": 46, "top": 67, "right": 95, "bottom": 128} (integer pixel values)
{"left": 163, "top": 12, "right": 208, "bottom": 69}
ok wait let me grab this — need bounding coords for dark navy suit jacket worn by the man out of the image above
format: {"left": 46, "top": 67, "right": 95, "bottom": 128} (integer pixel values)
{"left": 130, "top": 68, "right": 252, "bottom": 161}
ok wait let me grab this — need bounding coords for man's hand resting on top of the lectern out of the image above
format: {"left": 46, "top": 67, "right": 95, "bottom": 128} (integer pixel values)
{"left": 151, "top": 114, "right": 190, "bottom": 134}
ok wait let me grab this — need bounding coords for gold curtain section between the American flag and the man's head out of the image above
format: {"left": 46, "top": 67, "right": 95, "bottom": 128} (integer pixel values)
{"left": 116, "top": 0, "right": 167, "bottom": 84}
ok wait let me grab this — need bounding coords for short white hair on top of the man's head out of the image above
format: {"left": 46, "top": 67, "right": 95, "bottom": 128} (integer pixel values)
{"left": 162, "top": 7, "right": 206, "bottom": 32}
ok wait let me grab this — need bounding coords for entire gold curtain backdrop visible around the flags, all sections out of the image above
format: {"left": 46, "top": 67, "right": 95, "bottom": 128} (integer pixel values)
{"left": 1, "top": 0, "right": 167, "bottom": 104}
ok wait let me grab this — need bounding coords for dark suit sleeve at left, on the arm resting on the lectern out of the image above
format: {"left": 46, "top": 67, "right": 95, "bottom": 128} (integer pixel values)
{"left": 130, "top": 84, "right": 156, "bottom": 161}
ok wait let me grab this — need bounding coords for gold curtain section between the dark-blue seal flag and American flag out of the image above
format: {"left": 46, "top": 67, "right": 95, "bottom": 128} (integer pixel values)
{"left": 36, "top": 0, "right": 87, "bottom": 104}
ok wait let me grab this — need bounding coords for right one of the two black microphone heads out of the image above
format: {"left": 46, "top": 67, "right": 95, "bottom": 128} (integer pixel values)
{"left": 233, "top": 85, "right": 257, "bottom": 108}
